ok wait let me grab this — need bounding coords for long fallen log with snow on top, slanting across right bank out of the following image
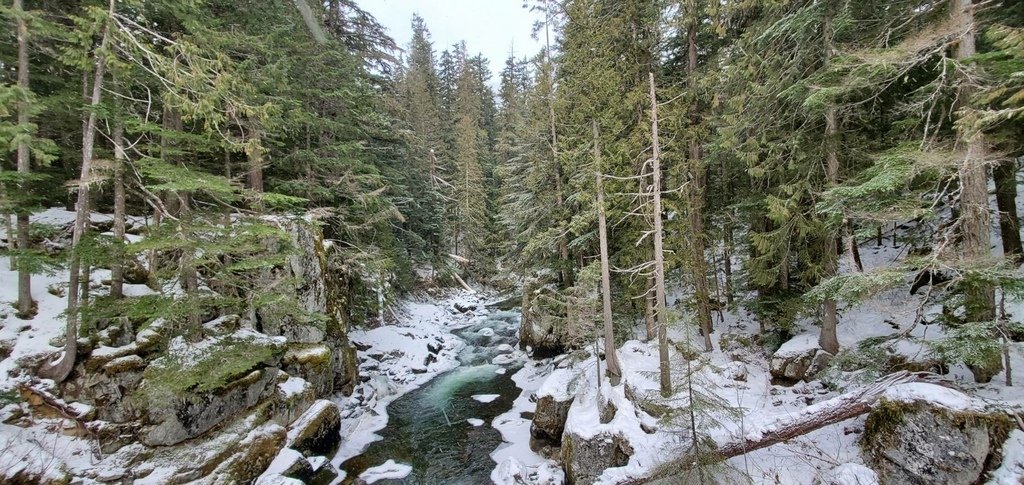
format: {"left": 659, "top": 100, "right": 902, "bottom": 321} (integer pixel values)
{"left": 624, "top": 370, "right": 938, "bottom": 484}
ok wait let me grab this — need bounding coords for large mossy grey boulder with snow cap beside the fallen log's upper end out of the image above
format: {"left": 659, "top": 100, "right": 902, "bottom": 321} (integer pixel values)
{"left": 861, "top": 400, "right": 1016, "bottom": 485}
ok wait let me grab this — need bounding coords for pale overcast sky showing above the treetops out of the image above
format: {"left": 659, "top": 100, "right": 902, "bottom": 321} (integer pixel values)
{"left": 358, "top": 0, "right": 543, "bottom": 85}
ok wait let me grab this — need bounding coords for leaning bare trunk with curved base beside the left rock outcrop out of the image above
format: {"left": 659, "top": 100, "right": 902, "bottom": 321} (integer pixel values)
{"left": 39, "top": 0, "right": 115, "bottom": 383}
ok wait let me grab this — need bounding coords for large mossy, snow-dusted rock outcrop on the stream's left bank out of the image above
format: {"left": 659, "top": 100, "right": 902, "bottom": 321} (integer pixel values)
{"left": 6, "top": 222, "right": 358, "bottom": 483}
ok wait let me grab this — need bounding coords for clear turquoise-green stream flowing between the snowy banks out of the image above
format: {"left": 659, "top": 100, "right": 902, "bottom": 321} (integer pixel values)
{"left": 342, "top": 311, "right": 521, "bottom": 484}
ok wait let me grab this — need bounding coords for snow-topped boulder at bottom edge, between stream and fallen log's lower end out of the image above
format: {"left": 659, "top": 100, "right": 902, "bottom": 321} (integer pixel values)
{"left": 561, "top": 433, "right": 633, "bottom": 485}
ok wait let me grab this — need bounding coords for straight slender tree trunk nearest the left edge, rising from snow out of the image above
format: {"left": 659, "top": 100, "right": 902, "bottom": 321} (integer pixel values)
{"left": 14, "top": 0, "right": 32, "bottom": 318}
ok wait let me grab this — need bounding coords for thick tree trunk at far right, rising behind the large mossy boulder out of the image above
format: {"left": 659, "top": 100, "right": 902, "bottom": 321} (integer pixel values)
{"left": 950, "top": 0, "right": 1002, "bottom": 383}
